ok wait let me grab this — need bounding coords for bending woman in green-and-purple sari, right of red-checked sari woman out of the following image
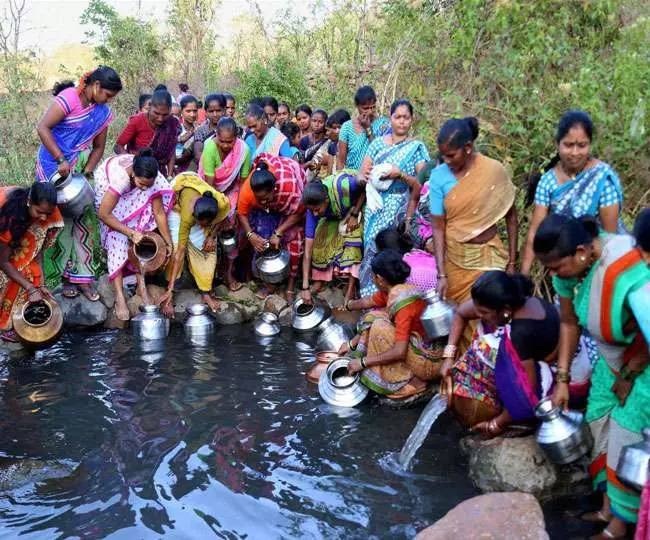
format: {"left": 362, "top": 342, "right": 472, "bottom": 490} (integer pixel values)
{"left": 301, "top": 170, "right": 363, "bottom": 303}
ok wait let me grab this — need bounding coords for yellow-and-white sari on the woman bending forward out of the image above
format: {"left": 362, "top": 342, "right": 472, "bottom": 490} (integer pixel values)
{"left": 166, "top": 172, "right": 230, "bottom": 294}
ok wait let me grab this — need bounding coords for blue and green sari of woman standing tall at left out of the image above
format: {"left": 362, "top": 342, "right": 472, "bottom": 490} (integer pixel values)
{"left": 36, "top": 87, "right": 113, "bottom": 287}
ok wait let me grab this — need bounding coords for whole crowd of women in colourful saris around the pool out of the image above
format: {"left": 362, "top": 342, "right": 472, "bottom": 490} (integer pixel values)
{"left": 0, "top": 67, "right": 650, "bottom": 538}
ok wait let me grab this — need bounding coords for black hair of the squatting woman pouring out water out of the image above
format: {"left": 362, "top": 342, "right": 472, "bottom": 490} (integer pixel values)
{"left": 472, "top": 270, "right": 535, "bottom": 311}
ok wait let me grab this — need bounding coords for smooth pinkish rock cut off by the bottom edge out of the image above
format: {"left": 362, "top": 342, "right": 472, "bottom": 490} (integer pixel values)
{"left": 416, "top": 493, "right": 549, "bottom": 540}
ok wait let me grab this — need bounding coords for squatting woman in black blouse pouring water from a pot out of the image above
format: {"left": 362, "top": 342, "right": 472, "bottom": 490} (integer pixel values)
{"left": 440, "top": 270, "right": 560, "bottom": 436}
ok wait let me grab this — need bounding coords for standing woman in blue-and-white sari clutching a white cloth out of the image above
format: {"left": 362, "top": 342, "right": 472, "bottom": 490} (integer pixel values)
{"left": 356, "top": 99, "right": 430, "bottom": 296}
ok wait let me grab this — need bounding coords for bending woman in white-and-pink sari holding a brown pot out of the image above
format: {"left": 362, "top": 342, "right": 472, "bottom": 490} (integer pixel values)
{"left": 95, "top": 149, "right": 174, "bottom": 321}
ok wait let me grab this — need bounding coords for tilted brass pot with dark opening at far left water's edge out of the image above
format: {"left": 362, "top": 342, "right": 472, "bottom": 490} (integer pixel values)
{"left": 12, "top": 298, "right": 63, "bottom": 349}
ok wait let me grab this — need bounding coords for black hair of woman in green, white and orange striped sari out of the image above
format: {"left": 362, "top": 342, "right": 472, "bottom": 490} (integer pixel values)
{"left": 533, "top": 214, "right": 598, "bottom": 259}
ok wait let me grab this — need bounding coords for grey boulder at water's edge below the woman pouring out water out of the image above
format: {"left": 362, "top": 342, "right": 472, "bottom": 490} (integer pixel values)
{"left": 461, "top": 435, "right": 589, "bottom": 500}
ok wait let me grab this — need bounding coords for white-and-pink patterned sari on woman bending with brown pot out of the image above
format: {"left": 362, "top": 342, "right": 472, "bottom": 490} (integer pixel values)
{"left": 95, "top": 154, "right": 174, "bottom": 280}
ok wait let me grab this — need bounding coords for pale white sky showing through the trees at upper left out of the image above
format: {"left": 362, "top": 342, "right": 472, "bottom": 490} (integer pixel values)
{"left": 12, "top": 0, "right": 307, "bottom": 54}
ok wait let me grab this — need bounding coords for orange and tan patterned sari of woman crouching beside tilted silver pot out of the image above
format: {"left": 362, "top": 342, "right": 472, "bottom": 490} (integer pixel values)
{"left": 359, "top": 284, "right": 443, "bottom": 395}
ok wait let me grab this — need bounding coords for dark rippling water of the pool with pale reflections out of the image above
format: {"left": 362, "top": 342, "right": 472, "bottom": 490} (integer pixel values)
{"left": 0, "top": 326, "right": 476, "bottom": 539}
